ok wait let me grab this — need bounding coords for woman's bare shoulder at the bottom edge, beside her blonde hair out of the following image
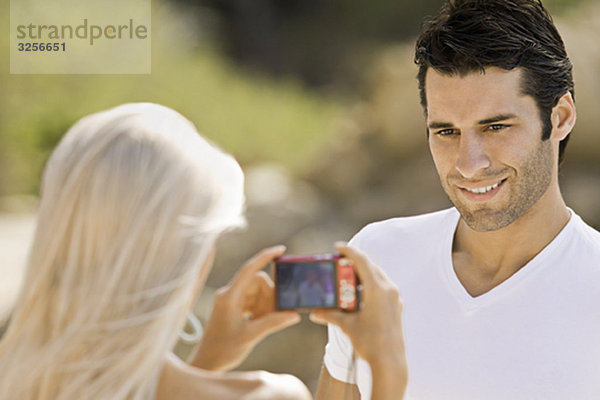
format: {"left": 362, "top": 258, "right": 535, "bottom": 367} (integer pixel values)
{"left": 156, "top": 359, "right": 312, "bottom": 400}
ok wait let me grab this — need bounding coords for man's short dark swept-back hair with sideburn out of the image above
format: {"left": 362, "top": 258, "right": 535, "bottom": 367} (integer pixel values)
{"left": 415, "top": 0, "right": 575, "bottom": 163}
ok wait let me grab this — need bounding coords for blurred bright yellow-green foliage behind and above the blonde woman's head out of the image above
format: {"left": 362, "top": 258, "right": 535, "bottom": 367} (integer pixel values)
{"left": 0, "top": 0, "right": 340, "bottom": 195}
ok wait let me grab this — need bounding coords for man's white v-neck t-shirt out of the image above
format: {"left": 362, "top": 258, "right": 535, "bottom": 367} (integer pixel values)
{"left": 324, "top": 208, "right": 600, "bottom": 400}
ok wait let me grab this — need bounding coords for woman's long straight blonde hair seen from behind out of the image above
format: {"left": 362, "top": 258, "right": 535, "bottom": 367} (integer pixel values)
{"left": 0, "top": 103, "right": 244, "bottom": 400}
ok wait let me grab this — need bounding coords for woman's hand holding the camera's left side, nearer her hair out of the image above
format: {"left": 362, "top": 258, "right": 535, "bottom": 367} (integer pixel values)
{"left": 191, "top": 246, "right": 300, "bottom": 370}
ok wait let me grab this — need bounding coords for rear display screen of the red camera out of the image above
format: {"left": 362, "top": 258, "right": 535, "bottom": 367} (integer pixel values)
{"left": 275, "top": 261, "right": 337, "bottom": 310}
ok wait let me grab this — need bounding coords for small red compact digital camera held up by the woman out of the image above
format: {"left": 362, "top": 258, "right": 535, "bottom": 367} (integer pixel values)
{"left": 273, "top": 254, "right": 360, "bottom": 311}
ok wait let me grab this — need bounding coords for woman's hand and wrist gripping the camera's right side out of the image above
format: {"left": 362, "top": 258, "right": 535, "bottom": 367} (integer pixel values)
{"left": 310, "top": 243, "right": 408, "bottom": 400}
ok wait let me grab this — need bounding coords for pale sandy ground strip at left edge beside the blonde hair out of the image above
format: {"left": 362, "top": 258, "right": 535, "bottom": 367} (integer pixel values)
{"left": 0, "top": 214, "right": 34, "bottom": 326}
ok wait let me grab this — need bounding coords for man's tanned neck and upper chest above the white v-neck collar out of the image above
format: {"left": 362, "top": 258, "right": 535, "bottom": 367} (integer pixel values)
{"left": 452, "top": 189, "right": 570, "bottom": 296}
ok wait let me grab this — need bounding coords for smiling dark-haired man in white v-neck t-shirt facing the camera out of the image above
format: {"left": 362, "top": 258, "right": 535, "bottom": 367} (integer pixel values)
{"left": 317, "top": 0, "right": 600, "bottom": 400}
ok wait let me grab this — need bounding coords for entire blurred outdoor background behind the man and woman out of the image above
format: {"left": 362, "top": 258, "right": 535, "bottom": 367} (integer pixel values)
{"left": 0, "top": 0, "right": 600, "bottom": 391}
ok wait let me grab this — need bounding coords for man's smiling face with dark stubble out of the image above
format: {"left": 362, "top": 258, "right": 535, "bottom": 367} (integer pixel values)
{"left": 425, "top": 67, "right": 557, "bottom": 231}
